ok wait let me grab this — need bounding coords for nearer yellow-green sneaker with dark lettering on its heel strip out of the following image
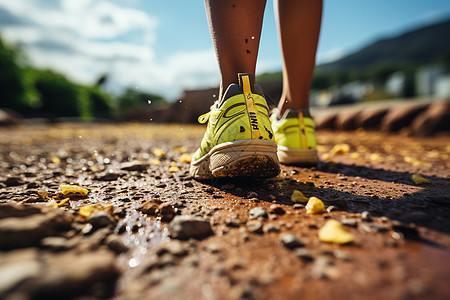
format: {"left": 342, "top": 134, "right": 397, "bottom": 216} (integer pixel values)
{"left": 190, "top": 74, "right": 280, "bottom": 179}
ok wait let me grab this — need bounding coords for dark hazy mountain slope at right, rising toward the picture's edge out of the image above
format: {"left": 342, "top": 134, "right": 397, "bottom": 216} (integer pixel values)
{"left": 317, "top": 19, "right": 450, "bottom": 70}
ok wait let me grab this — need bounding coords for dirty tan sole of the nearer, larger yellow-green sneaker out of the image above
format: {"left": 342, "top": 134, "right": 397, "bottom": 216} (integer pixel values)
{"left": 190, "top": 140, "right": 280, "bottom": 179}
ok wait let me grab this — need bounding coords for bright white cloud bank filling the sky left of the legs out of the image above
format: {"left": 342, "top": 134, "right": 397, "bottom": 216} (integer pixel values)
{"left": 0, "top": 0, "right": 219, "bottom": 99}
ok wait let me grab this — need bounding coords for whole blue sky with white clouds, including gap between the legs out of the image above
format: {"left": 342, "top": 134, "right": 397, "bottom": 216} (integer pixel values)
{"left": 0, "top": 0, "right": 450, "bottom": 100}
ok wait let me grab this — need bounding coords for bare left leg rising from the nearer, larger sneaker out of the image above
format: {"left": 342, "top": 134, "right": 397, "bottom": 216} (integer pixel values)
{"left": 205, "top": 0, "right": 266, "bottom": 99}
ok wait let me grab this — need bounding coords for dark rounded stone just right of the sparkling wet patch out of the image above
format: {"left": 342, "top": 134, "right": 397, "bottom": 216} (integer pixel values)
{"left": 169, "top": 215, "right": 213, "bottom": 239}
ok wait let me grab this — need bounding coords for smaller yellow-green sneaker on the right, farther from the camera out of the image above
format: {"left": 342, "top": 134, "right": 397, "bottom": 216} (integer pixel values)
{"left": 270, "top": 108, "right": 319, "bottom": 165}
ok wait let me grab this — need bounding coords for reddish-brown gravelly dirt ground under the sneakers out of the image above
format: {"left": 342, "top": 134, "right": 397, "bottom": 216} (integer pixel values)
{"left": 0, "top": 124, "right": 450, "bottom": 299}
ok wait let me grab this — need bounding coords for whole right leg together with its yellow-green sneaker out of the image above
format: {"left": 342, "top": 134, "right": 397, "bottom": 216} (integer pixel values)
{"left": 271, "top": 0, "right": 322, "bottom": 165}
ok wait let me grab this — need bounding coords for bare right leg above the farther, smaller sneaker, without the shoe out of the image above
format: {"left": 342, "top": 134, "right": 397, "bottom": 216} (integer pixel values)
{"left": 274, "top": 0, "right": 322, "bottom": 115}
